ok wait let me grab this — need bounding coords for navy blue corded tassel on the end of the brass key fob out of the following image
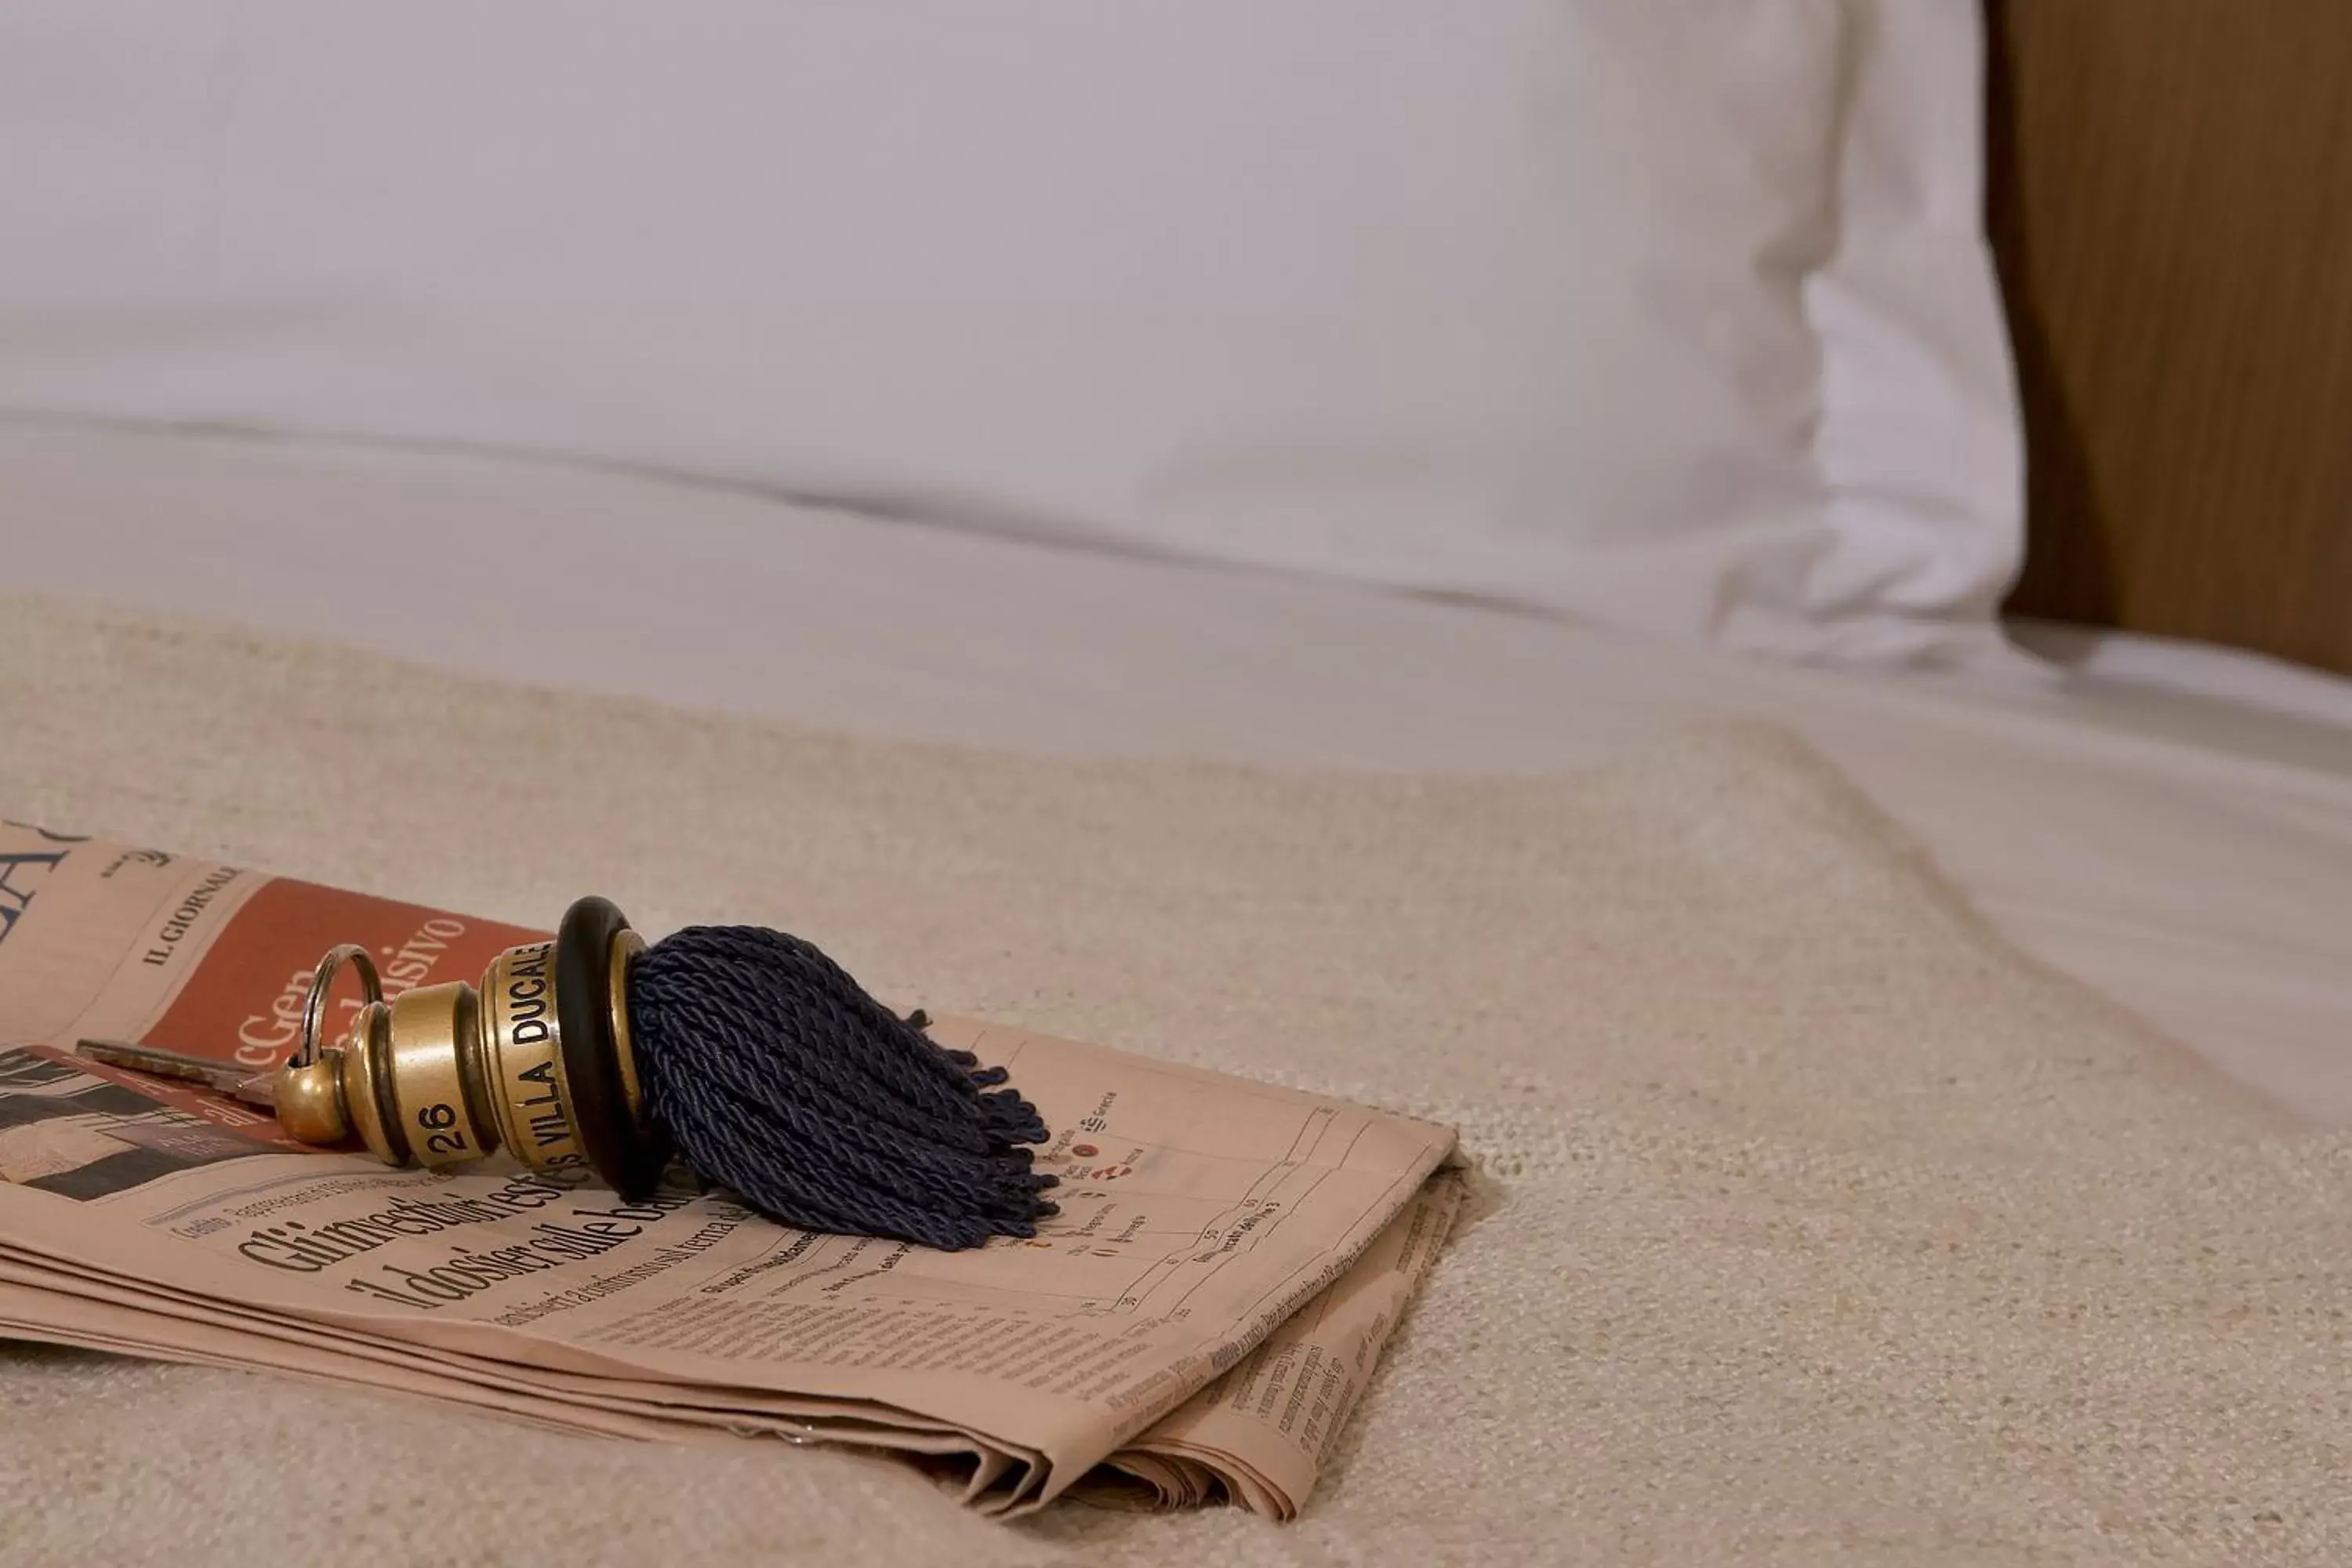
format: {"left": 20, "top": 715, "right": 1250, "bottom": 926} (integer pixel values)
{"left": 628, "top": 926, "right": 1056, "bottom": 1250}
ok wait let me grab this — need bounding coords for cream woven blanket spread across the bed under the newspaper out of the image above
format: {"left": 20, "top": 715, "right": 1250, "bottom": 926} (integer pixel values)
{"left": 0, "top": 602, "right": 2352, "bottom": 1568}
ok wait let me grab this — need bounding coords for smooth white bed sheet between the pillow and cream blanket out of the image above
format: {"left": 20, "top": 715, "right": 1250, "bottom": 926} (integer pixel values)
{"left": 13, "top": 426, "right": 2352, "bottom": 1123}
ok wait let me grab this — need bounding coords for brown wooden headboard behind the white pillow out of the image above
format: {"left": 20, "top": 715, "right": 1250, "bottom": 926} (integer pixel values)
{"left": 1987, "top": 0, "right": 2352, "bottom": 670}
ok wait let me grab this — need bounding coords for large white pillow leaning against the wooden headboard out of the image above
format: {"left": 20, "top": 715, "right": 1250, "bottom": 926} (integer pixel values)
{"left": 0, "top": 0, "right": 2020, "bottom": 659}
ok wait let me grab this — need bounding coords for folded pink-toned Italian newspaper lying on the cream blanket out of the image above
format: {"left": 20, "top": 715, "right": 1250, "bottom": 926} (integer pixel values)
{"left": 0, "top": 825, "right": 1461, "bottom": 1519}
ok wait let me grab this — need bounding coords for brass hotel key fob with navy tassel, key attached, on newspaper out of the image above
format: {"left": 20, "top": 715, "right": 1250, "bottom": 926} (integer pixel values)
{"left": 80, "top": 895, "right": 1061, "bottom": 1250}
